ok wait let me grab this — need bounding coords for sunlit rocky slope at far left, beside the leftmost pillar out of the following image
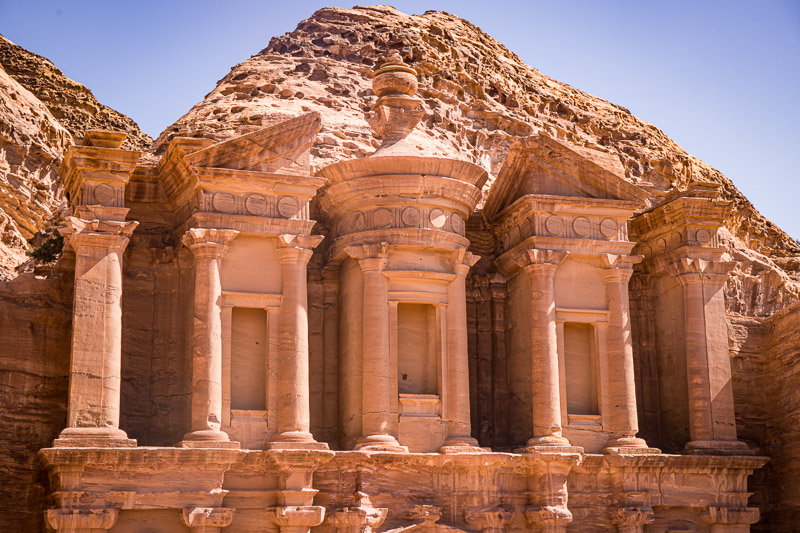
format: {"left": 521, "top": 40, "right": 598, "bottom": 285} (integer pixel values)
{"left": 0, "top": 35, "right": 152, "bottom": 280}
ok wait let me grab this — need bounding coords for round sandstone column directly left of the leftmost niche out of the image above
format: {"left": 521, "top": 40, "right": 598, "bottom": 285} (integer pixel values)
{"left": 179, "top": 229, "right": 239, "bottom": 448}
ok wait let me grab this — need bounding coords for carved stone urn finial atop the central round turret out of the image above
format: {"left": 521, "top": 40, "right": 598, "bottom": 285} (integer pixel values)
{"left": 367, "top": 51, "right": 425, "bottom": 156}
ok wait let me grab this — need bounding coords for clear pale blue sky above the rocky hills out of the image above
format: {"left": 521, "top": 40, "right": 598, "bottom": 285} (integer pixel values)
{"left": 0, "top": 0, "right": 800, "bottom": 238}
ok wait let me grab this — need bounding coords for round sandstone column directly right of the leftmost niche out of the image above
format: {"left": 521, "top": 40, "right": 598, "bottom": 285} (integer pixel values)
{"left": 268, "top": 235, "right": 328, "bottom": 449}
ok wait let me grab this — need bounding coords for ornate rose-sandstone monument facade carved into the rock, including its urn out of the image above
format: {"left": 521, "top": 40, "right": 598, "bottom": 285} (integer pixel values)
{"left": 31, "top": 54, "right": 767, "bottom": 533}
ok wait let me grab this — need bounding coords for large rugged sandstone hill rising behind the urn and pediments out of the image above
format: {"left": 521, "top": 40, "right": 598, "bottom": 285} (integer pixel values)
{"left": 155, "top": 6, "right": 800, "bottom": 316}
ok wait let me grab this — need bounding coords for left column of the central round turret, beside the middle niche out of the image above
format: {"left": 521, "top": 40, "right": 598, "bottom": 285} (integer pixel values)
{"left": 347, "top": 242, "right": 408, "bottom": 452}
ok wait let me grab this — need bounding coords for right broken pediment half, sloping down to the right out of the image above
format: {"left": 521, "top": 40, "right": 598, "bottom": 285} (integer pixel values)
{"left": 484, "top": 135, "right": 648, "bottom": 218}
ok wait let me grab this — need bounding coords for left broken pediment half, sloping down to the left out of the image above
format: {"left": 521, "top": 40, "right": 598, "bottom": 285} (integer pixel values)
{"left": 184, "top": 112, "right": 322, "bottom": 174}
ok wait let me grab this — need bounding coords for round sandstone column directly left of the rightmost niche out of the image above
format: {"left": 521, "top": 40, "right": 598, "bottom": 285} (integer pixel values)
{"left": 517, "top": 249, "right": 569, "bottom": 447}
